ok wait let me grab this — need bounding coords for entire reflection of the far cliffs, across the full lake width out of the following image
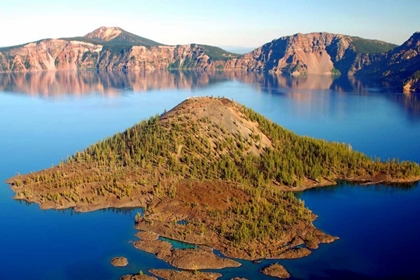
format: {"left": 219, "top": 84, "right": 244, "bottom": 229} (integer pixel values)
{"left": 0, "top": 71, "right": 420, "bottom": 119}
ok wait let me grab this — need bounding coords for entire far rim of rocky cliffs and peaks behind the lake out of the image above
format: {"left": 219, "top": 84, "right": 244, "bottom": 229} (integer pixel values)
{"left": 0, "top": 27, "right": 420, "bottom": 91}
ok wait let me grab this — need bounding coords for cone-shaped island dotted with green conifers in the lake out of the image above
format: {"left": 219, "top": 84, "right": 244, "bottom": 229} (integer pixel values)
{"left": 7, "top": 97, "right": 420, "bottom": 279}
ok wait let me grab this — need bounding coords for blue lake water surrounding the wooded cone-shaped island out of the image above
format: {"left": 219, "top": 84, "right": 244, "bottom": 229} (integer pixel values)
{"left": 0, "top": 72, "right": 420, "bottom": 279}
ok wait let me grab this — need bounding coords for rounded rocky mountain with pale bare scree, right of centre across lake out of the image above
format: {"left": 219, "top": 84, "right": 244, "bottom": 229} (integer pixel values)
{"left": 225, "top": 32, "right": 396, "bottom": 75}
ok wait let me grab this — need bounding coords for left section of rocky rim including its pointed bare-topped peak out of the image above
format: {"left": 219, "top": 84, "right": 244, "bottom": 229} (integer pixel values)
{"left": 0, "top": 27, "right": 237, "bottom": 72}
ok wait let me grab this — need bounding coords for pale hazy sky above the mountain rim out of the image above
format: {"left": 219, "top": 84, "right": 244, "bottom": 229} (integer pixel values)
{"left": 0, "top": 0, "right": 420, "bottom": 47}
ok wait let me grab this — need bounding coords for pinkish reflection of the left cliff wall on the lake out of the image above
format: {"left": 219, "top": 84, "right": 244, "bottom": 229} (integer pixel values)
{"left": 0, "top": 71, "right": 227, "bottom": 97}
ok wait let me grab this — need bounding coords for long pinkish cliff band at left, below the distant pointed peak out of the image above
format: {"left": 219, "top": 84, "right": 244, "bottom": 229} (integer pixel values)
{"left": 0, "top": 39, "right": 234, "bottom": 72}
